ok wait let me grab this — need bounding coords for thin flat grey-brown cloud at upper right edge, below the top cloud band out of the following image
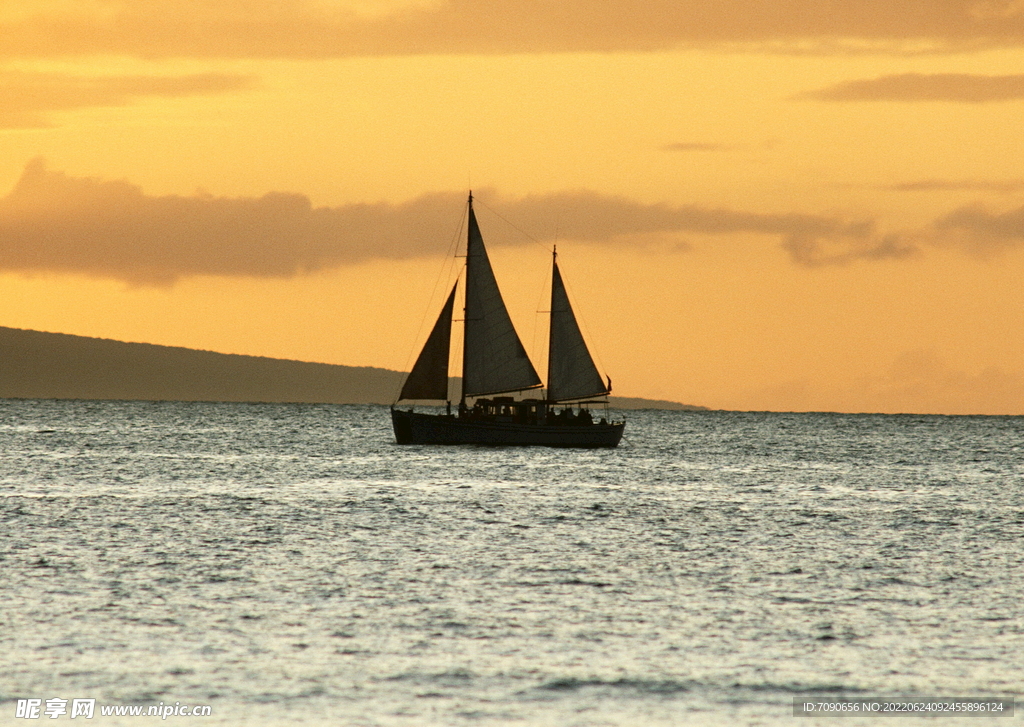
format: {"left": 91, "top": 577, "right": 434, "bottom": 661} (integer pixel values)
{"left": 795, "top": 73, "right": 1024, "bottom": 103}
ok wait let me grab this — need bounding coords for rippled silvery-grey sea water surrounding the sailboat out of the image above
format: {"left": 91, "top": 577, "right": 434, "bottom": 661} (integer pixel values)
{"left": 0, "top": 400, "right": 1024, "bottom": 727}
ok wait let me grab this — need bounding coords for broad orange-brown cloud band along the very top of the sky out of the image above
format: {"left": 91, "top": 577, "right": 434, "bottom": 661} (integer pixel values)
{"left": 6, "top": 0, "right": 1024, "bottom": 58}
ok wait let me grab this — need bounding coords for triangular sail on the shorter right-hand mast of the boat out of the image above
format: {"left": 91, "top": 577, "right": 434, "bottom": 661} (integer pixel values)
{"left": 548, "top": 260, "right": 611, "bottom": 401}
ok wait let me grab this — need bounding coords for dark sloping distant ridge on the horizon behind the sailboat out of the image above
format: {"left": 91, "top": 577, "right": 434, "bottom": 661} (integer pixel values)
{"left": 0, "top": 327, "right": 700, "bottom": 410}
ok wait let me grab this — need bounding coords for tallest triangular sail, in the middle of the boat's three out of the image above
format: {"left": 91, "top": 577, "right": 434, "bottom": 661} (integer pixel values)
{"left": 462, "top": 196, "right": 541, "bottom": 397}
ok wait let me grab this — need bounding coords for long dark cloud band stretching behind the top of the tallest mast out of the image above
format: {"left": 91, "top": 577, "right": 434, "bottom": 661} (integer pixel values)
{"left": 0, "top": 160, "right": 914, "bottom": 285}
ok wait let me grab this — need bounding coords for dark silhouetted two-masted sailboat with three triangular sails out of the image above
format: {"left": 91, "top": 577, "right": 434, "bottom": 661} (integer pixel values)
{"left": 391, "top": 193, "right": 626, "bottom": 447}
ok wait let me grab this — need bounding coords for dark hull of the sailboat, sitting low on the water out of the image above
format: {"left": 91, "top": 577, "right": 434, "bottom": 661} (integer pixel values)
{"left": 391, "top": 409, "right": 626, "bottom": 448}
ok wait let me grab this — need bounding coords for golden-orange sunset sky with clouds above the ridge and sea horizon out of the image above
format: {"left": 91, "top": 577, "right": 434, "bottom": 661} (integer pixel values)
{"left": 0, "top": 0, "right": 1024, "bottom": 415}
